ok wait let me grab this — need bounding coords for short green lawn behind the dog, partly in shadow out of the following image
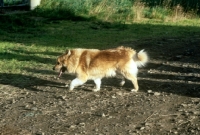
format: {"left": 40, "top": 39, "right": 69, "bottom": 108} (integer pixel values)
{"left": 0, "top": 0, "right": 200, "bottom": 84}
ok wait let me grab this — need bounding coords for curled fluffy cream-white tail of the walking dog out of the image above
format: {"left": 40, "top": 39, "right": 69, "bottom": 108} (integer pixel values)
{"left": 133, "top": 50, "right": 149, "bottom": 67}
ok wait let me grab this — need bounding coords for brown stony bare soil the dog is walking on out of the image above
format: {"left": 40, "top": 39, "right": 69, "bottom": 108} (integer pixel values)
{"left": 0, "top": 34, "right": 200, "bottom": 135}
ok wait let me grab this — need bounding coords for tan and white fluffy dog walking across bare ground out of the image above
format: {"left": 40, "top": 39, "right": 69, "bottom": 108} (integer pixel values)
{"left": 53, "top": 46, "right": 149, "bottom": 92}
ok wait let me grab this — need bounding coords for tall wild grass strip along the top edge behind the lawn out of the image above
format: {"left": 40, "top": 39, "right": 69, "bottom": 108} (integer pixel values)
{"left": 35, "top": 0, "right": 200, "bottom": 23}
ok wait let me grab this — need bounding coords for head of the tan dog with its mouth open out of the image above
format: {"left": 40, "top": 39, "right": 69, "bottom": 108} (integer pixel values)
{"left": 53, "top": 50, "right": 71, "bottom": 77}
